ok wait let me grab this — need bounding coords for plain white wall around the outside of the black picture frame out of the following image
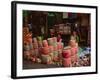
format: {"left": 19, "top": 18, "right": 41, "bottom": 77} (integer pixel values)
{"left": 0, "top": 0, "right": 100, "bottom": 80}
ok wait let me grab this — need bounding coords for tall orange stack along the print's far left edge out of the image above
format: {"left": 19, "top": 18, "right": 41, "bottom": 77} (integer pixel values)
{"left": 23, "top": 27, "right": 34, "bottom": 61}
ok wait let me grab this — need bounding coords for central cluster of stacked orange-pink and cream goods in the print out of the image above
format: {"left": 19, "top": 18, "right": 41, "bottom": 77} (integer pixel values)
{"left": 41, "top": 37, "right": 63, "bottom": 64}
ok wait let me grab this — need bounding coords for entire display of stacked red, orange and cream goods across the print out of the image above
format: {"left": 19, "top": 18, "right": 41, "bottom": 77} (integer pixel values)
{"left": 23, "top": 27, "right": 91, "bottom": 67}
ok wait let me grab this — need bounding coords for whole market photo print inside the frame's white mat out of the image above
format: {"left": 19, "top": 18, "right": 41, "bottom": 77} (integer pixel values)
{"left": 23, "top": 10, "right": 91, "bottom": 69}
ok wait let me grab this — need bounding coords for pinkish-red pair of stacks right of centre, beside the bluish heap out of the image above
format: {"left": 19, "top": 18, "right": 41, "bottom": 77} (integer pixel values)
{"left": 62, "top": 40, "right": 78, "bottom": 67}
